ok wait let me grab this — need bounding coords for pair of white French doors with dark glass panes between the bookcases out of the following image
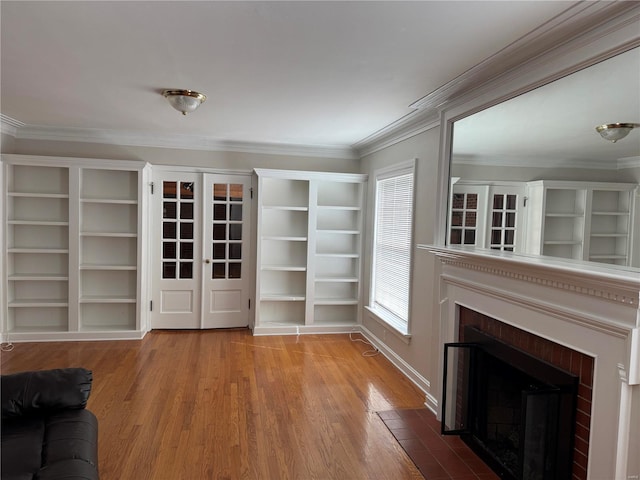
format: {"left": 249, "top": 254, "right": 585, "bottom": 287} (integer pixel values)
{"left": 151, "top": 171, "right": 251, "bottom": 329}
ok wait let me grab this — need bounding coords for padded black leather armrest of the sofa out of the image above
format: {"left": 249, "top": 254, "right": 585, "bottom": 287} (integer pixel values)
{"left": 0, "top": 368, "right": 93, "bottom": 418}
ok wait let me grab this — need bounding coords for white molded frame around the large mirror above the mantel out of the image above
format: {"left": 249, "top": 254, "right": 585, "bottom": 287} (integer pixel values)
{"left": 434, "top": 8, "right": 640, "bottom": 269}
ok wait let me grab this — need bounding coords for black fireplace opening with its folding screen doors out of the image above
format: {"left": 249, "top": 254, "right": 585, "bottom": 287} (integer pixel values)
{"left": 442, "top": 326, "right": 578, "bottom": 480}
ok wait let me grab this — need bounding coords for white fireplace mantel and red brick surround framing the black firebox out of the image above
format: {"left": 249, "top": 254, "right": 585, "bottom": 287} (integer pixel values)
{"left": 419, "top": 245, "right": 640, "bottom": 480}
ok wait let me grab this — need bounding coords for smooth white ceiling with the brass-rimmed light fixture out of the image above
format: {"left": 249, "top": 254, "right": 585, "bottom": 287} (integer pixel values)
{"left": 0, "top": 0, "right": 584, "bottom": 154}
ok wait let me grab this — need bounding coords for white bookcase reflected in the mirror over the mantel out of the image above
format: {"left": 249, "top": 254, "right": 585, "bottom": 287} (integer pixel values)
{"left": 528, "top": 181, "right": 637, "bottom": 265}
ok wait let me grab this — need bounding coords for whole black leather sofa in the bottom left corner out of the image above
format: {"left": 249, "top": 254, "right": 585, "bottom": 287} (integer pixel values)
{"left": 0, "top": 368, "right": 99, "bottom": 480}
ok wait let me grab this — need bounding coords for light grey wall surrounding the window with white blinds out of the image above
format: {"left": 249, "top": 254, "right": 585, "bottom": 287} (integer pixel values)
{"left": 362, "top": 128, "right": 440, "bottom": 404}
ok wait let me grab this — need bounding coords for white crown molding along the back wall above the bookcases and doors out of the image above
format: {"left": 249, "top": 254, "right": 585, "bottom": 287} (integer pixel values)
{"left": 3, "top": 123, "right": 358, "bottom": 160}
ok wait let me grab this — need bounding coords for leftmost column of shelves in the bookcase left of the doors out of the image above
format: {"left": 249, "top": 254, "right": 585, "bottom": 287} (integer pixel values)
{"left": 5, "top": 165, "right": 69, "bottom": 332}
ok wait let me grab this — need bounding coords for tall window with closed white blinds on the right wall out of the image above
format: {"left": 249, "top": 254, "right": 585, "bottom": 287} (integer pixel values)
{"left": 369, "top": 160, "right": 415, "bottom": 334}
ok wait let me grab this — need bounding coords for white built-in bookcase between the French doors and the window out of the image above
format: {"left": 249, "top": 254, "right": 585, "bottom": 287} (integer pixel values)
{"left": 254, "top": 169, "right": 366, "bottom": 334}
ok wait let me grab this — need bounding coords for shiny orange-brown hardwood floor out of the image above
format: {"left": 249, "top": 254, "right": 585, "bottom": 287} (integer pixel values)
{"left": 1, "top": 330, "right": 424, "bottom": 480}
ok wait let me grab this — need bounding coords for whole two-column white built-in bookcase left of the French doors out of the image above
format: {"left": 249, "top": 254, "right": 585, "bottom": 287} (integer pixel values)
{"left": 2, "top": 155, "right": 148, "bottom": 341}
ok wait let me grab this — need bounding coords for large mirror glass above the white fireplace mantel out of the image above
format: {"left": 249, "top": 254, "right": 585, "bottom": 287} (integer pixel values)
{"left": 446, "top": 47, "right": 640, "bottom": 270}
